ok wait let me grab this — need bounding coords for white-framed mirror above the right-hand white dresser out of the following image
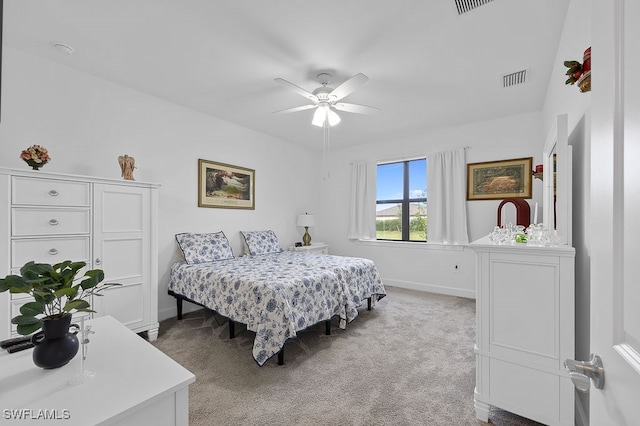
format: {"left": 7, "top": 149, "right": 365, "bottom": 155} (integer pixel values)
{"left": 542, "top": 114, "right": 572, "bottom": 245}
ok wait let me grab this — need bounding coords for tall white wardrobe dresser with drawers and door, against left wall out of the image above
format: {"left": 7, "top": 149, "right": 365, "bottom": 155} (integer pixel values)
{"left": 0, "top": 168, "right": 159, "bottom": 340}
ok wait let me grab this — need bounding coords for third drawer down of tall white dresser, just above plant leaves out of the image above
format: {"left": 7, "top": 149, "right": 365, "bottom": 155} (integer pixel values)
{"left": 11, "top": 236, "right": 91, "bottom": 269}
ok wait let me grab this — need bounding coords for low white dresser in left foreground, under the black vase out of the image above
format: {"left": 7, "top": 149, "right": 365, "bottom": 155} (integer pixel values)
{"left": 0, "top": 316, "right": 195, "bottom": 426}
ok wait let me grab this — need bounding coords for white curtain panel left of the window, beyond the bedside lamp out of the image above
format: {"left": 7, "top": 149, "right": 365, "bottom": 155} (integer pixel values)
{"left": 348, "top": 162, "right": 375, "bottom": 240}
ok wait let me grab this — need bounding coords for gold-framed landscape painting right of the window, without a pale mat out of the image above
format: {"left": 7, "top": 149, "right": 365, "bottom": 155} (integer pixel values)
{"left": 467, "top": 157, "right": 533, "bottom": 200}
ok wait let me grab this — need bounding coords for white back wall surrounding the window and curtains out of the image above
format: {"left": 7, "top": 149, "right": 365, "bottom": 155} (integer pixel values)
{"left": 315, "top": 111, "right": 546, "bottom": 298}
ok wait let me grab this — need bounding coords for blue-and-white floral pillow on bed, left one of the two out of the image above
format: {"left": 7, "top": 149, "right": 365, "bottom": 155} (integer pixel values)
{"left": 176, "top": 231, "right": 233, "bottom": 264}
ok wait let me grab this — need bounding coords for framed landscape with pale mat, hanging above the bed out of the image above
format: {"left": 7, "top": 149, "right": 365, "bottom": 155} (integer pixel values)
{"left": 198, "top": 159, "right": 256, "bottom": 210}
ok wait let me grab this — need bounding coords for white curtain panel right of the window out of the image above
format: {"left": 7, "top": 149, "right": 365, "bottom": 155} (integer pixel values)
{"left": 427, "top": 148, "right": 469, "bottom": 244}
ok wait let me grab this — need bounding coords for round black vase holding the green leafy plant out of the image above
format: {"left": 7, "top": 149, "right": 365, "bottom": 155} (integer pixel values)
{"left": 31, "top": 315, "right": 80, "bottom": 369}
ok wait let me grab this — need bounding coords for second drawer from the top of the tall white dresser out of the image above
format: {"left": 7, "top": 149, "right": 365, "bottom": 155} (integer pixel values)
{"left": 11, "top": 208, "right": 91, "bottom": 237}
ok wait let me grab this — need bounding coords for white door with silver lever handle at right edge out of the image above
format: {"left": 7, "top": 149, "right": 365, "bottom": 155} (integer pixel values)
{"left": 590, "top": 0, "right": 640, "bottom": 426}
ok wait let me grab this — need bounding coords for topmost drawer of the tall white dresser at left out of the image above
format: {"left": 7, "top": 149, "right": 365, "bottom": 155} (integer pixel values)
{"left": 11, "top": 176, "right": 91, "bottom": 207}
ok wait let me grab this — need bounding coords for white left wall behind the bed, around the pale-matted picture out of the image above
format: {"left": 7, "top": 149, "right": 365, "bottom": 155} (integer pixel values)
{"left": 0, "top": 47, "right": 321, "bottom": 319}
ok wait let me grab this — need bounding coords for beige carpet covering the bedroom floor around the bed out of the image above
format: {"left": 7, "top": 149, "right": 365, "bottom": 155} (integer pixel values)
{"left": 153, "top": 287, "right": 538, "bottom": 426}
